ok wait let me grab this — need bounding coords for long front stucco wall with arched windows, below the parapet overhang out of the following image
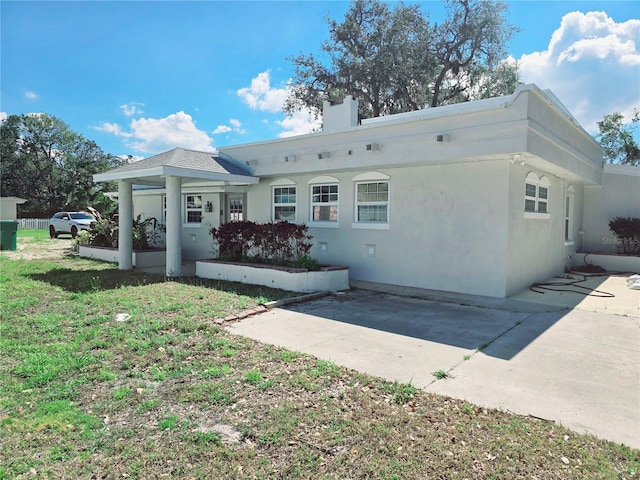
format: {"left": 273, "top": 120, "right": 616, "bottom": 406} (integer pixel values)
{"left": 248, "top": 161, "right": 508, "bottom": 297}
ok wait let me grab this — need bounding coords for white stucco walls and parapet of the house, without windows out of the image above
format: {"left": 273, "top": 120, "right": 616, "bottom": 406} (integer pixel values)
{"left": 122, "top": 86, "right": 608, "bottom": 297}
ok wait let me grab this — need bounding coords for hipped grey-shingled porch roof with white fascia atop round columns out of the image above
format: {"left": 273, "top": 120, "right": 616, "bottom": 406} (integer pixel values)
{"left": 93, "top": 148, "right": 259, "bottom": 186}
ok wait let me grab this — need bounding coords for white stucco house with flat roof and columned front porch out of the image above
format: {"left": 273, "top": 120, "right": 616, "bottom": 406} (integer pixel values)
{"left": 94, "top": 85, "right": 640, "bottom": 297}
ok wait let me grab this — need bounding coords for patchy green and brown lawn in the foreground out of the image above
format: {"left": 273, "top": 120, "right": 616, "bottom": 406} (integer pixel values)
{"left": 0, "top": 238, "right": 640, "bottom": 480}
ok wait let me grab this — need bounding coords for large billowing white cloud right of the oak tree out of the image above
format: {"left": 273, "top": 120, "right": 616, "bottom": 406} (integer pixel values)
{"left": 518, "top": 12, "right": 640, "bottom": 133}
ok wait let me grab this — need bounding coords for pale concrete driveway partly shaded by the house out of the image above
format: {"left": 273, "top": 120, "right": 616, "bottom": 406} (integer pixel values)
{"left": 228, "top": 290, "right": 640, "bottom": 448}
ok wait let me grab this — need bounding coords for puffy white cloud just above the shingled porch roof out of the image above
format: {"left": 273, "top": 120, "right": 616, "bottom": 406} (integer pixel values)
{"left": 97, "top": 111, "right": 214, "bottom": 153}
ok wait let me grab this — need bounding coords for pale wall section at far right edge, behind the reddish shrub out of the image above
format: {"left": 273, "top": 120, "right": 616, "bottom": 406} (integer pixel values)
{"left": 581, "top": 165, "right": 640, "bottom": 253}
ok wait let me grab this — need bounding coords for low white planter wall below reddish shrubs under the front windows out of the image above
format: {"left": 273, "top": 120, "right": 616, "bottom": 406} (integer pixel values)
{"left": 196, "top": 260, "right": 349, "bottom": 293}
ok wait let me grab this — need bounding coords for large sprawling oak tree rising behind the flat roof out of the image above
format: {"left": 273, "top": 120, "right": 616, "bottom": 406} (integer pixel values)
{"left": 285, "top": 0, "right": 519, "bottom": 118}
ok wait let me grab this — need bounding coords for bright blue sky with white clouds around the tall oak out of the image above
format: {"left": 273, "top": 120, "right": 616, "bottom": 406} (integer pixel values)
{"left": 0, "top": 0, "right": 640, "bottom": 158}
